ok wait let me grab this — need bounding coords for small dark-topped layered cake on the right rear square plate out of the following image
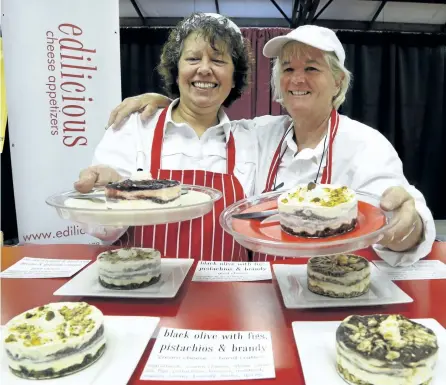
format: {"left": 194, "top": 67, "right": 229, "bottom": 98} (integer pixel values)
{"left": 307, "top": 254, "right": 370, "bottom": 298}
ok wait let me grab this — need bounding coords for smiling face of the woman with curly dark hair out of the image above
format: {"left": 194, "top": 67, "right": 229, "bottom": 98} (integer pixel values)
{"left": 177, "top": 32, "right": 234, "bottom": 110}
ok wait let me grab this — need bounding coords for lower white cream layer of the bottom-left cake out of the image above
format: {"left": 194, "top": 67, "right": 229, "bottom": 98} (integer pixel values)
{"left": 8, "top": 335, "right": 106, "bottom": 372}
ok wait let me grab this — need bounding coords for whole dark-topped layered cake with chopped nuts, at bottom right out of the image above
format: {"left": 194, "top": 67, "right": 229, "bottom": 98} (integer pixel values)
{"left": 336, "top": 314, "right": 438, "bottom": 385}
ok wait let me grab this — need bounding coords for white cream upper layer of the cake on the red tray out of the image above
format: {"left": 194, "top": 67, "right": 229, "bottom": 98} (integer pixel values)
{"left": 278, "top": 184, "right": 358, "bottom": 219}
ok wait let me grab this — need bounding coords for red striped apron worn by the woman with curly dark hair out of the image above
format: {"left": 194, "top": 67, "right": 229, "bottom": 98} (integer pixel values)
{"left": 116, "top": 108, "right": 248, "bottom": 261}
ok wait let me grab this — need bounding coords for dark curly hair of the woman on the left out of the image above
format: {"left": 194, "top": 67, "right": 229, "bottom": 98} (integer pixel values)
{"left": 158, "top": 13, "right": 252, "bottom": 107}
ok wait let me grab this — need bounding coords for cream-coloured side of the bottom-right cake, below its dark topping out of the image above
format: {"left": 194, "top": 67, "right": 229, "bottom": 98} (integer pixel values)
{"left": 336, "top": 343, "right": 437, "bottom": 385}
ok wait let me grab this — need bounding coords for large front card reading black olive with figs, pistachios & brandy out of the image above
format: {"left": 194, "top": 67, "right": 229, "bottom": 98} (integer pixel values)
{"left": 141, "top": 327, "right": 276, "bottom": 381}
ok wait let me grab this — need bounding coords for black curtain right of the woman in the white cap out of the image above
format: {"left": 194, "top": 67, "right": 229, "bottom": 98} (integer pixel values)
{"left": 338, "top": 32, "right": 446, "bottom": 219}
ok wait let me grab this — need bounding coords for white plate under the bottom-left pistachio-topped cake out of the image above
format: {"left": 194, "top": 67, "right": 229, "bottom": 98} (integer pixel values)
{"left": 0, "top": 316, "right": 159, "bottom": 385}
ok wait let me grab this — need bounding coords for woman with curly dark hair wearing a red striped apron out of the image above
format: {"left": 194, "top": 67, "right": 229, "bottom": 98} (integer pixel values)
{"left": 75, "top": 13, "right": 256, "bottom": 260}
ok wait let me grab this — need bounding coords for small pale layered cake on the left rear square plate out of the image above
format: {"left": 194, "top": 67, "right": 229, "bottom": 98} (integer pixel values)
{"left": 97, "top": 247, "right": 161, "bottom": 290}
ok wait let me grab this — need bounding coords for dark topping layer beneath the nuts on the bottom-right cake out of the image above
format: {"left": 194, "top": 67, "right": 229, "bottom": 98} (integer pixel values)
{"left": 336, "top": 314, "right": 438, "bottom": 368}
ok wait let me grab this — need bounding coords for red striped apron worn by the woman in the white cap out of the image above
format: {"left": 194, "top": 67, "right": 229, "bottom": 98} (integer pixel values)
{"left": 253, "top": 109, "right": 339, "bottom": 261}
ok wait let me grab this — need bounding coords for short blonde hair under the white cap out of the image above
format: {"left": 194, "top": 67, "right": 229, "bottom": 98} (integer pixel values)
{"left": 271, "top": 41, "right": 352, "bottom": 110}
